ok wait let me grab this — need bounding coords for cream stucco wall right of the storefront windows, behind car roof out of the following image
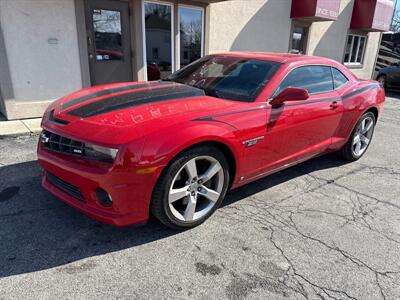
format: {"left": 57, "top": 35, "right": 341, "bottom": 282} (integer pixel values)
{"left": 206, "top": 0, "right": 380, "bottom": 79}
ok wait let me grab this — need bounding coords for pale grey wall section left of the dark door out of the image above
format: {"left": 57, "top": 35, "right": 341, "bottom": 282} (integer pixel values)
{"left": 0, "top": 0, "right": 82, "bottom": 102}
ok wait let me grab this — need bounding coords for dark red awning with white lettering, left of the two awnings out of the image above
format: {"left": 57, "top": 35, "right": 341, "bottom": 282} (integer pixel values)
{"left": 290, "top": 0, "right": 340, "bottom": 21}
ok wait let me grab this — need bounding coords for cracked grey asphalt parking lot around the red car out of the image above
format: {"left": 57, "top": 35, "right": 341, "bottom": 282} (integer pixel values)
{"left": 0, "top": 98, "right": 400, "bottom": 299}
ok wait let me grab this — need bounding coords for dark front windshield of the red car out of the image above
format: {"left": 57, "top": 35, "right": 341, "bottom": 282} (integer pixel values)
{"left": 166, "top": 56, "right": 281, "bottom": 102}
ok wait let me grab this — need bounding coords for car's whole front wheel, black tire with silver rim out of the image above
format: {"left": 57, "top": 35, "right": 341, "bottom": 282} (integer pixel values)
{"left": 151, "top": 145, "right": 230, "bottom": 229}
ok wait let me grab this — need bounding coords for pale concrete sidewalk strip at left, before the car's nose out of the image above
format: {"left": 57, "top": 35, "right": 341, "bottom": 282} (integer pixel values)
{"left": 0, "top": 118, "right": 42, "bottom": 138}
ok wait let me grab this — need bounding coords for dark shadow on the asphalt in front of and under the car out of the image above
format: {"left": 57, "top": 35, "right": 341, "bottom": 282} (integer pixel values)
{"left": 0, "top": 156, "right": 344, "bottom": 277}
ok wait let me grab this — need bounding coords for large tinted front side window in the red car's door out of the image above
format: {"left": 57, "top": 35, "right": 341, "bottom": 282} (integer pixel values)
{"left": 276, "top": 66, "right": 333, "bottom": 94}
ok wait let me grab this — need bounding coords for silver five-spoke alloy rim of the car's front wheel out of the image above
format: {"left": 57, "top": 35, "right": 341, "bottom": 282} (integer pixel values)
{"left": 168, "top": 156, "right": 225, "bottom": 222}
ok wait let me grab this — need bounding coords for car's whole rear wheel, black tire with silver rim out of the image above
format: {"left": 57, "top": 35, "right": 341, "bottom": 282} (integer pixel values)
{"left": 338, "top": 112, "right": 376, "bottom": 161}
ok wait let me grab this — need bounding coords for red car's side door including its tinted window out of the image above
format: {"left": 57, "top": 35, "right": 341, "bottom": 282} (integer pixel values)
{"left": 239, "top": 65, "right": 343, "bottom": 178}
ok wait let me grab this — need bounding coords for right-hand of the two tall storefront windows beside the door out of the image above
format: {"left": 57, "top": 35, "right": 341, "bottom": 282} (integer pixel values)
{"left": 179, "top": 6, "right": 203, "bottom": 67}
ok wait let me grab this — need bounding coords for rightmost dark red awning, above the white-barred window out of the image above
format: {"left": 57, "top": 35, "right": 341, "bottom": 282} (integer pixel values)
{"left": 350, "top": 0, "right": 394, "bottom": 31}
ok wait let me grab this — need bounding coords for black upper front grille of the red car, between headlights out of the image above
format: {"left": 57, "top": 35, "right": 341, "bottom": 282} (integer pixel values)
{"left": 40, "top": 130, "right": 85, "bottom": 156}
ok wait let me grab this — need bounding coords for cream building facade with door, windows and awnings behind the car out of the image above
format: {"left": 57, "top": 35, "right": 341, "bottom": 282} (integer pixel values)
{"left": 0, "top": 0, "right": 394, "bottom": 119}
